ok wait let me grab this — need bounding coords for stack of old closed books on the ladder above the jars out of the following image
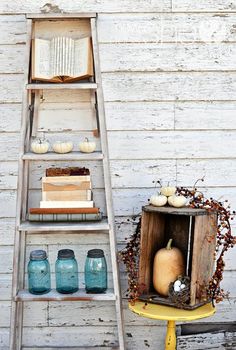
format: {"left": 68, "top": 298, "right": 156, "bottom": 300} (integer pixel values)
{"left": 29, "top": 168, "right": 101, "bottom": 221}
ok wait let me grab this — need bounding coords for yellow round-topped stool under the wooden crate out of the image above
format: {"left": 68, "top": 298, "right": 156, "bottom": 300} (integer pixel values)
{"left": 129, "top": 301, "right": 215, "bottom": 350}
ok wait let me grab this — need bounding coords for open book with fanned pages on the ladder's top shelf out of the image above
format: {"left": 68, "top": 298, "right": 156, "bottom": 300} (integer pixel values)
{"left": 32, "top": 37, "right": 93, "bottom": 83}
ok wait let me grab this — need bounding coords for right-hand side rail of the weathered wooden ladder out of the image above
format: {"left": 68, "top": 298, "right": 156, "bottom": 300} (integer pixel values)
{"left": 90, "top": 18, "right": 125, "bottom": 350}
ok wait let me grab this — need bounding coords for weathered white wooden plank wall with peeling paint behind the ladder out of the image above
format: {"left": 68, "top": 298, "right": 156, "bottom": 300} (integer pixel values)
{"left": 0, "top": 0, "right": 236, "bottom": 350}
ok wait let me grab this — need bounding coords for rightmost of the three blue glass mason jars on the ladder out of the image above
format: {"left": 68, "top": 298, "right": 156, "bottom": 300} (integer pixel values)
{"left": 85, "top": 249, "right": 107, "bottom": 293}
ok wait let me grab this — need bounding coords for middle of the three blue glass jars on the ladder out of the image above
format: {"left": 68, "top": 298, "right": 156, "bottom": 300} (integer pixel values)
{"left": 56, "top": 249, "right": 79, "bottom": 294}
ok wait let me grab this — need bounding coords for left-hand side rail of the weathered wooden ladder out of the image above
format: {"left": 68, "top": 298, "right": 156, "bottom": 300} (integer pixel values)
{"left": 9, "top": 19, "right": 32, "bottom": 350}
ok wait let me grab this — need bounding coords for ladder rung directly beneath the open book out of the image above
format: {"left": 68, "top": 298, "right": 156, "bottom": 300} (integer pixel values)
{"left": 26, "top": 83, "right": 97, "bottom": 90}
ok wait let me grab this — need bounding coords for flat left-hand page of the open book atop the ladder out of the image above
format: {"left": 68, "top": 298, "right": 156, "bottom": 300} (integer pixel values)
{"left": 32, "top": 38, "right": 52, "bottom": 79}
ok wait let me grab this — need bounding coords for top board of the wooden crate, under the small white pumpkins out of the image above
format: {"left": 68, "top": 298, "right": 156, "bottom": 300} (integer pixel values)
{"left": 142, "top": 205, "right": 207, "bottom": 216}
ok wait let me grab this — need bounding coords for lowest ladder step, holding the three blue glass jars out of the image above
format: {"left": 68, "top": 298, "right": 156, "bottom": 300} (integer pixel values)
{"left": 15, "top": 289, "right": 116, "bottom": 301}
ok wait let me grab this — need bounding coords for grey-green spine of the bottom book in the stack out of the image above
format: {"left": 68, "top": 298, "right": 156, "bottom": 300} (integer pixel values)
{"left": 28, "top": 213, "right": 102, "bottom": 222}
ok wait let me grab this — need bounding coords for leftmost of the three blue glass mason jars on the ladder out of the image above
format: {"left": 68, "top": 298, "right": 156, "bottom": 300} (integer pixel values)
{"left": 28, "top": 250, "right": 51, "bottom": 294}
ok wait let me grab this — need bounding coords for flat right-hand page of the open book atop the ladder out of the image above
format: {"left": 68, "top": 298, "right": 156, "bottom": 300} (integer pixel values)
{"left": 73, "top": 38, "right": 91, "bottom": 77}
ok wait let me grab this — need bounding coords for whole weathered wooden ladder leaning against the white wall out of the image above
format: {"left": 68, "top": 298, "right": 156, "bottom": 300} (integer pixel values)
{"left": 10, "top": 13, "right": 125, "bottom": 350}
